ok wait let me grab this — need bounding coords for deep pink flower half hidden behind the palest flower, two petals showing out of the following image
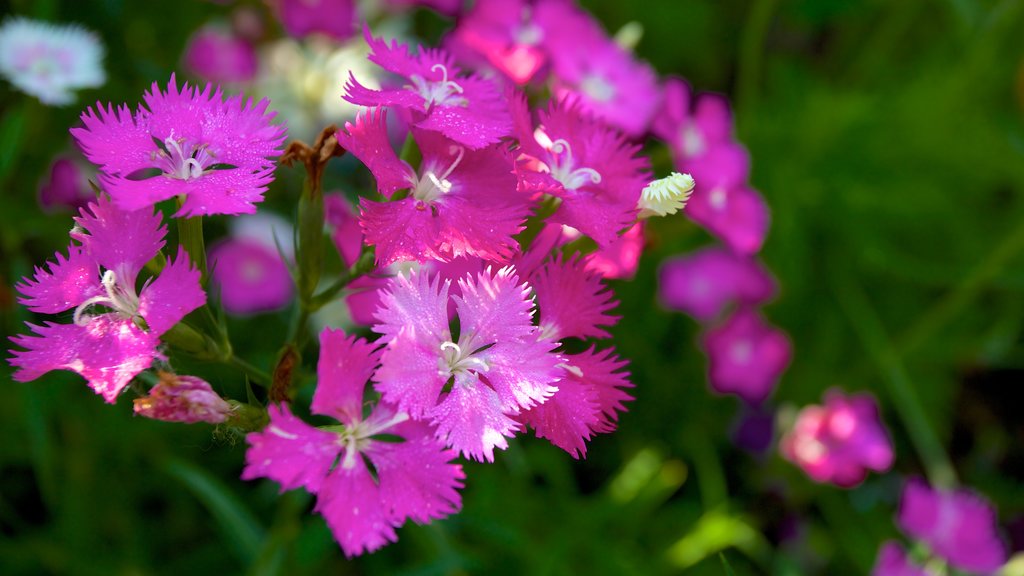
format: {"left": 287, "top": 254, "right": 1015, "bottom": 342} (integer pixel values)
{"left": 517, "top": 256, "right": 633, "bottom": 458}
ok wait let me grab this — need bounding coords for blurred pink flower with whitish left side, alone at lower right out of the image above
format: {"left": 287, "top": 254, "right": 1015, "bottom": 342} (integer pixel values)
{"left": 779, "top": 389, "right": 893, "bottom": 488}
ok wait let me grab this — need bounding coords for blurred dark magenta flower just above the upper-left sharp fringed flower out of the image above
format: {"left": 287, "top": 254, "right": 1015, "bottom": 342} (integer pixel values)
{"left": 184, "top": 25, "right": 259, "bottom": 83}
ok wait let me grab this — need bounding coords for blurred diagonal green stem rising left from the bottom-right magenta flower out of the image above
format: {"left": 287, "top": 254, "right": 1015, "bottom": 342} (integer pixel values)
{"left": 830, "top": 270, "right": 956, "bottom": 488}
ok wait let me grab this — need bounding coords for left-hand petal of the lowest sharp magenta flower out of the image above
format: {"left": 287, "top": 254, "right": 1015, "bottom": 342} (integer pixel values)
{"left": 242, "top": 405, "right": 341, "bottom": 493}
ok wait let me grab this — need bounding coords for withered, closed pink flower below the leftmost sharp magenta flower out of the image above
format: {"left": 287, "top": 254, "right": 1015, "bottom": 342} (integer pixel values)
{"left": 134, "top": 372, "right": 231, "bottom": 424}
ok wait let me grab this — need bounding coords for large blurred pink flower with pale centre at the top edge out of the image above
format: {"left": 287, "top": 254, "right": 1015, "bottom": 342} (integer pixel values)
{"left": 535, "top": 1, "right": 662, "bottom": 135}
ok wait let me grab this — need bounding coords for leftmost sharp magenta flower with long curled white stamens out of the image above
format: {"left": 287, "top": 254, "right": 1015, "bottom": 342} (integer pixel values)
{"left": 9, "top": 198, "right": 206, "bottom": 403}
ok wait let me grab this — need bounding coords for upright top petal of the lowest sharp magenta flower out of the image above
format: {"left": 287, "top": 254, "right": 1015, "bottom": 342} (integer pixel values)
{"left": 312, "top": 328, "right": 381, "bottom": 424}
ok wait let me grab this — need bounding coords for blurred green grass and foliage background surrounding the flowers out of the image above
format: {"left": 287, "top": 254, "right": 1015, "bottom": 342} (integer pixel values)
{"left": 0, "top": 0, "right": 1024, "bottom": 575}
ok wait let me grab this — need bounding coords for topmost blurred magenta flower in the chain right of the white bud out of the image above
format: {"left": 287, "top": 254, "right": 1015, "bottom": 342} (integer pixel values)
{"left": 651, "top": 78, "right": 733, "bottom": 167}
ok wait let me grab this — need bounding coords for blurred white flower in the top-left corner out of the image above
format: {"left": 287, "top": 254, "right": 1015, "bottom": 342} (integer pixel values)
{"left": 0, "top": 17, "right": 106, "bottom": 105}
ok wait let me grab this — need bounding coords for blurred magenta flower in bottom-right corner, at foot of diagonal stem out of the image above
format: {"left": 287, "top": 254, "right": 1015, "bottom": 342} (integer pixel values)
{"left": 897, "top": 480, "right": 1007, "bottom": 574}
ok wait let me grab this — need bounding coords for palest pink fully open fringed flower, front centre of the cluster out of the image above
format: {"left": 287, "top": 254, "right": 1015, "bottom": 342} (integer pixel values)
{"left": 374, "top": 268, "right": 561, "bottom": 461}
